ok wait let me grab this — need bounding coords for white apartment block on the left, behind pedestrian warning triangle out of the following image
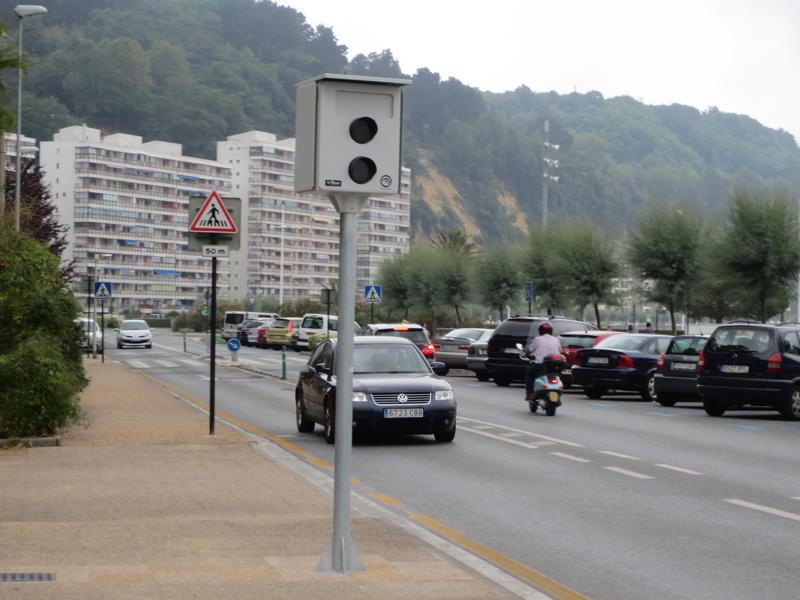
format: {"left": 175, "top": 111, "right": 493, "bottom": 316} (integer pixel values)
{"left": 40, "top": 125, "right": 231, "bottom": 312}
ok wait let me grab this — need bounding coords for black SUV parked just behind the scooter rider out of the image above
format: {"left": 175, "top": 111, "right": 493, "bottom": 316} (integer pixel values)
{"left": 486, "top": 315, "right": 595, "bottom": 386}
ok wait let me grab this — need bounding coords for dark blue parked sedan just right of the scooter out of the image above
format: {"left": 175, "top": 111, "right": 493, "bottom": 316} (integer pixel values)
{"left": 572, "top": 333, "right": 672, "bottom": 401}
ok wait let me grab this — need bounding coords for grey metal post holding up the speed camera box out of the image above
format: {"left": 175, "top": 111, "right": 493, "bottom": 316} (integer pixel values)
{"left": 317, "top": 196, "right": 366, "bottom": 573}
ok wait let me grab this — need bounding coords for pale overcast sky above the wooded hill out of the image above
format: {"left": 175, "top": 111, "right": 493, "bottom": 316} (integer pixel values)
{"left": 279, "top": 0, "right": 800, "bottom": 140}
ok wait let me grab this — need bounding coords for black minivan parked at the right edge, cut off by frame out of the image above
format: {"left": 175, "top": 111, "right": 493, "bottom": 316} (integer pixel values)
{"left": 697, "top": 323, "right": 800, "bottom": 421}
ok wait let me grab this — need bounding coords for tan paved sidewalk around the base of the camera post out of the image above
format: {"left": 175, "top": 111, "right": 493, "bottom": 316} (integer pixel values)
{"left": 0, "top": 362, "right": 510, "bottom": 600}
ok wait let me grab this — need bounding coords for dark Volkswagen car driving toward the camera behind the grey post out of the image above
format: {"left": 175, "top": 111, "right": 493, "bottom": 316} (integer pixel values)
{"left": 295, "top": 336, "right": 456, "bottom": 444}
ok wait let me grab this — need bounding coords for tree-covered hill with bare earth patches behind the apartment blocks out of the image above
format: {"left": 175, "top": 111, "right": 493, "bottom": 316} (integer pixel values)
{"left": 7, "top": 0, "right": 800, "bottom": 242}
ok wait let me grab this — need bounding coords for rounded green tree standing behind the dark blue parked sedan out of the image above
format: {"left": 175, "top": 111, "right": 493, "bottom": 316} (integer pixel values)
{"left": 628, "top": 206, "right": 704, "bottom": 335}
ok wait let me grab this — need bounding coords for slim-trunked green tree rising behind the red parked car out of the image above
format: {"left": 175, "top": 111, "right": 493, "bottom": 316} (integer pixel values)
{"left": 557, "top": 224, "right": 620, "bottom": 328}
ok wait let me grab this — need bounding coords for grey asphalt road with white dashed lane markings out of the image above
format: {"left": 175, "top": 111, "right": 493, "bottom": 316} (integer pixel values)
{"left": 103, "top": 333, "right": 800, "bottom": 600}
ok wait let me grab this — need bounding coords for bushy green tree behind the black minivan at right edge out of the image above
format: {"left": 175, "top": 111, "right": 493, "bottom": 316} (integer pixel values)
{"left": 721, "top": 188, "right": 800, "bottom": 322}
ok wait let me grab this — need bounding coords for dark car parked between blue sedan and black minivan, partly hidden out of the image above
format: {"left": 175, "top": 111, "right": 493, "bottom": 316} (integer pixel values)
{"left": 655, "top": 335, "right": 708, "bottom": 406}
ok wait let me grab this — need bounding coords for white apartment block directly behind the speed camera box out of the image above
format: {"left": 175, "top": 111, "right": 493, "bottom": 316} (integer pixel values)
{"left": 217, "top": 131, "right": 411, "bottom": 301}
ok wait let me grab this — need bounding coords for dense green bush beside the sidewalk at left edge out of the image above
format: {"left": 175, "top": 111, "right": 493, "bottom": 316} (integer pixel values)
{"left": 0, "top": 228, "right": 88, "bottom": 437}
